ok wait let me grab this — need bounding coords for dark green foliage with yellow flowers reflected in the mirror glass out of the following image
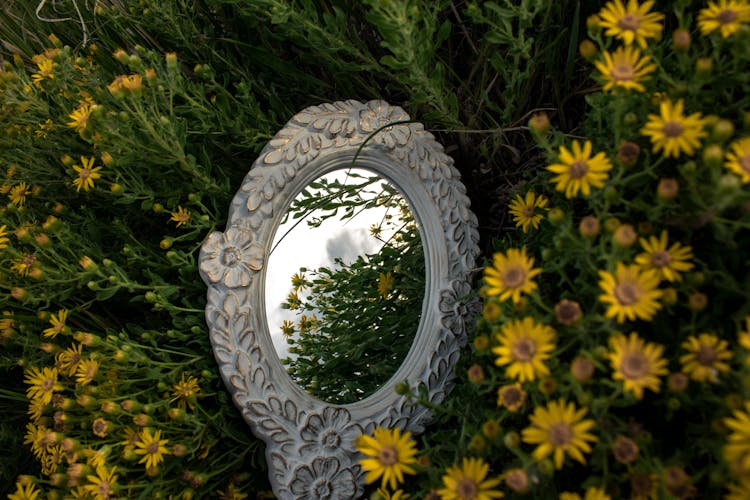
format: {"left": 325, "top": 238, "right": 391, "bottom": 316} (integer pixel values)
{"left": 282, "top": 172, "right": 425, "bottom": 404}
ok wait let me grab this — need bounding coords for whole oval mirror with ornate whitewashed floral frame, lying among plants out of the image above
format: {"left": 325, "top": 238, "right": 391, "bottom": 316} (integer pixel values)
{"left": 199, "top": 101, "right": 478, "bottom": 500}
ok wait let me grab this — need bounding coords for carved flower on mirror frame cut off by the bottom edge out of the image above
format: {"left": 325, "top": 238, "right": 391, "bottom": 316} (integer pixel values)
{"left": 289, "top": 458, "right": 357, "bottom": 500}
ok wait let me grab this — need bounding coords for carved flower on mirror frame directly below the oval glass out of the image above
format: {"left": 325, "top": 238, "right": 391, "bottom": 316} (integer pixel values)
{"left": 300, "top": 406, "right": 362, "bottom": 456}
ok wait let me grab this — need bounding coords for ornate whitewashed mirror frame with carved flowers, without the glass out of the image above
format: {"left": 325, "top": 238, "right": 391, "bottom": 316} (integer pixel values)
{"left": 199, "top": 101, "right": 478, "bottom": 500}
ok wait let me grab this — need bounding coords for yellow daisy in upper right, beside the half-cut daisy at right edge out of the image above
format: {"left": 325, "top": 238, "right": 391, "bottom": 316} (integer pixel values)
{"left": 641, "top": 99, "right": 708, "bottom": 158}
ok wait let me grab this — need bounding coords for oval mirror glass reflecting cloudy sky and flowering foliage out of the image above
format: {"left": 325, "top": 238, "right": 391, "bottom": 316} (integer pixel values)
{"left": 265, "top": 169, "right": 425, "bottom": 404}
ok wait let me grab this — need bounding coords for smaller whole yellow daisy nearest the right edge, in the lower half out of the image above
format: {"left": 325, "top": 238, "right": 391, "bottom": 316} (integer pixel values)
{"left": 680, "top": 333, "right": 732, "bottom": 384}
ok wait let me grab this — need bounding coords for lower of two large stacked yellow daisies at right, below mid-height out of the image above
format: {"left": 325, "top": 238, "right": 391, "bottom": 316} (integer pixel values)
{"left": 608, "top": 332, "right": 669, "bottom": 399}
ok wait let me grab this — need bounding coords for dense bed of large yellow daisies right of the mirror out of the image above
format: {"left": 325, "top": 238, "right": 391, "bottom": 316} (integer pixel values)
{"left": 359, "top": 0, "right": 750, "bottom": 500}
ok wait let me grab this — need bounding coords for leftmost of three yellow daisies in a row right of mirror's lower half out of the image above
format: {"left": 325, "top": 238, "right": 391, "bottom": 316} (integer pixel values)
{"left": 492, "top": 316, "right": 555, "bottom": 382}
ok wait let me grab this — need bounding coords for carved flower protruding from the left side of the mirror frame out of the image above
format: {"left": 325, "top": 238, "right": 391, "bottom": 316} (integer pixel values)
{"left": 200, "top": 227, "right": 263, "bottom": 288}
